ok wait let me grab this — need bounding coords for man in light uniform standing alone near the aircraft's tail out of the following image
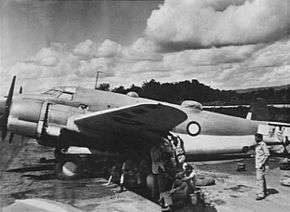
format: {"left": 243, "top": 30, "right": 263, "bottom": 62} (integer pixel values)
{"left": 255, "top": 133, "right": 270, "bottom": 200}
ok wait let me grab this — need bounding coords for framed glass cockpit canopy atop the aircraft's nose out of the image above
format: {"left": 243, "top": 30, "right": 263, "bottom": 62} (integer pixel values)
{"left": 42, "top": 86, "right": 76, "bottom": 100}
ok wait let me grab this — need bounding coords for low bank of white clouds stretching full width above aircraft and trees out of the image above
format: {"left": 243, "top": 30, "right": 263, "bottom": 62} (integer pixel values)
{"left": 0, "top": 34, "right": 290, "bottom": 94}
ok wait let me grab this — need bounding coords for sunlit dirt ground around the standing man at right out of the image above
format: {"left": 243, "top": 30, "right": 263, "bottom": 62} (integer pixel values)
{"left": 198, "top": 158, "right": 290, "bottom": 212}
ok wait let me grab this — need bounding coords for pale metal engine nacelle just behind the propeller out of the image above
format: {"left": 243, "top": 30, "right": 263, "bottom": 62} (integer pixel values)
{"left": 7, "top": 100, "right": 85, "bottom": 146}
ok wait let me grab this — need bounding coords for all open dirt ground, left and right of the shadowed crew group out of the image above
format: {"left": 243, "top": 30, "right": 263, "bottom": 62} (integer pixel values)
{"left": 0, "top": 137, "right": 290, "bottom": 212}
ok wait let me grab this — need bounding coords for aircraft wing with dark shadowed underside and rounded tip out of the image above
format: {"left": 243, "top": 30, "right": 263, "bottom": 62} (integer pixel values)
{"left": 74, "top": 103, "right": 187, "bottom": 135}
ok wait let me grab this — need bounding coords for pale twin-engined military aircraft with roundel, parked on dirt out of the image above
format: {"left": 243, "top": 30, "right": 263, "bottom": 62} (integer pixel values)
{"left": 0, "top": 77, "right": 290, "bottom": 177}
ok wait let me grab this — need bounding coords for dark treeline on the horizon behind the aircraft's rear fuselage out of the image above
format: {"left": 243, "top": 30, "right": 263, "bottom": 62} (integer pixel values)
{"left": 99, "top": 79, "right": 290, "bottom": 105}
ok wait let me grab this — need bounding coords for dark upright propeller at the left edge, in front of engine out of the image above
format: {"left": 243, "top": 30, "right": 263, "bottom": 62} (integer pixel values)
{"left": 0, "top": 76, "right": 16, "bottom": 140}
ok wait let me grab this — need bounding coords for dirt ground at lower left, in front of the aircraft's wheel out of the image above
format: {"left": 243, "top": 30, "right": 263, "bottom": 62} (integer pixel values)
{"left": 0, "top": 137, "right": 160, "bottom": 211}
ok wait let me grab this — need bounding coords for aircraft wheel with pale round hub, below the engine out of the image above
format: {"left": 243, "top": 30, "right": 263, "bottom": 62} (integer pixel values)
{"left": 56, "top": 157, "right": 81, "bottom": 180}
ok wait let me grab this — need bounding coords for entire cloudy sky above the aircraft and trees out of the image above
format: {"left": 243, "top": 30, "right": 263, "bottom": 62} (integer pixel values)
{"left": 0, "top": 0, "right": 290, "bottom": 94}
